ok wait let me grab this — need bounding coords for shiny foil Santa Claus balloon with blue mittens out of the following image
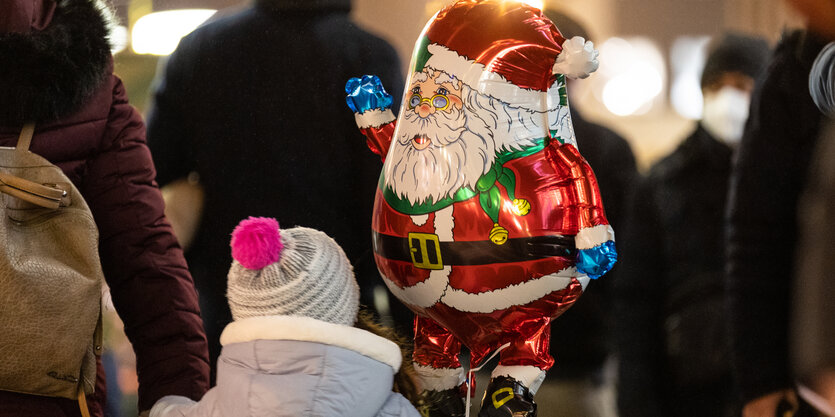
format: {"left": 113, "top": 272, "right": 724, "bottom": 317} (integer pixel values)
{"left": 346, "top": 0, "right": 617, "bottom": 416}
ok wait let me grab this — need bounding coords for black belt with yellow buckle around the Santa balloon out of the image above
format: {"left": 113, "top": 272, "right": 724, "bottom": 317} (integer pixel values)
{"left": 373, "top": 232, "right": 577, "bottom": 269}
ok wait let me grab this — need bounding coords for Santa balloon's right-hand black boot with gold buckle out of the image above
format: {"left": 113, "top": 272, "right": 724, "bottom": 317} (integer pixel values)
{"left": 478, "top": 376, "right": 536, "bottom": 417}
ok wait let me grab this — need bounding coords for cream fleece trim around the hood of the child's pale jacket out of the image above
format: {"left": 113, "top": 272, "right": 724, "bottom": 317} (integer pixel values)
{"left": 220, "top": 316, "right": 403, "bottom": 372}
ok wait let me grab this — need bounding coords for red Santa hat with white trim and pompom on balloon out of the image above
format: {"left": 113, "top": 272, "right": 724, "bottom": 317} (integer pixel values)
{"left": 412, "top": 0, "right": 598, "bottom": 111}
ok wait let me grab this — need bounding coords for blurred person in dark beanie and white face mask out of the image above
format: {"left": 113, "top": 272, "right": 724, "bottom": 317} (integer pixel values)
{"left": 614, "top": 34, "right": 769, "bottom": 417}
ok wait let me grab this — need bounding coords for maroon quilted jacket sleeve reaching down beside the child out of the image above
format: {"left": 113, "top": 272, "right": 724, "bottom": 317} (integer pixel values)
{"left": 82, "top": 76, "right": 209, "bottom": 410}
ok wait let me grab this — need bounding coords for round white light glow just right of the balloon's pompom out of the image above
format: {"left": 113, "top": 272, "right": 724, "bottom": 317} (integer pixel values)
{"left": 599, "top": 38, "right": 664, "bottom": 116}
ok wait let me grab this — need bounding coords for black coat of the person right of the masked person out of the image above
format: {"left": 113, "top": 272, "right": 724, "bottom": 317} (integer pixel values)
{"left": 728, "top": 32, "right": 823, "bottom": 402}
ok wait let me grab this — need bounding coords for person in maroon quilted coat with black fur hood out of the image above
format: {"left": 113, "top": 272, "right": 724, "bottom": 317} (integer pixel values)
{"left": 0, "top": 0, "right": 209, "bottom": 417}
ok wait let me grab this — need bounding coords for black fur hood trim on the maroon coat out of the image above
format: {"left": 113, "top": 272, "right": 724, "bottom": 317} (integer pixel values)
{"left": 0, "top": 0, "right": 112, "bottom": 126}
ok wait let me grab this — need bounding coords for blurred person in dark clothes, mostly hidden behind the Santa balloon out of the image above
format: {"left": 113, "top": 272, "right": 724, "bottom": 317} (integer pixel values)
{"left": 524, "top": 9, "right": 637, "bottom": 417}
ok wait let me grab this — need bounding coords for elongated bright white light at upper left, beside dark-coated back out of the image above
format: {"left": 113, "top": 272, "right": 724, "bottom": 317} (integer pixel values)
{"left": 131, "top": 9, "right": 215, "bottom": 55}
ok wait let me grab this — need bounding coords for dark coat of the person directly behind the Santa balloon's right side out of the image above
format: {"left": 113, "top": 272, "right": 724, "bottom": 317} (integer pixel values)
{"left": 546, "top": 109, "right": 638, "bottom": 381}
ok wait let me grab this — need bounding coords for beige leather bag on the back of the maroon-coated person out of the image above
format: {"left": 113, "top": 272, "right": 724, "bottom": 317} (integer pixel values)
{"left": 0, "top": 124, "right": 103, "bottom": 415}
